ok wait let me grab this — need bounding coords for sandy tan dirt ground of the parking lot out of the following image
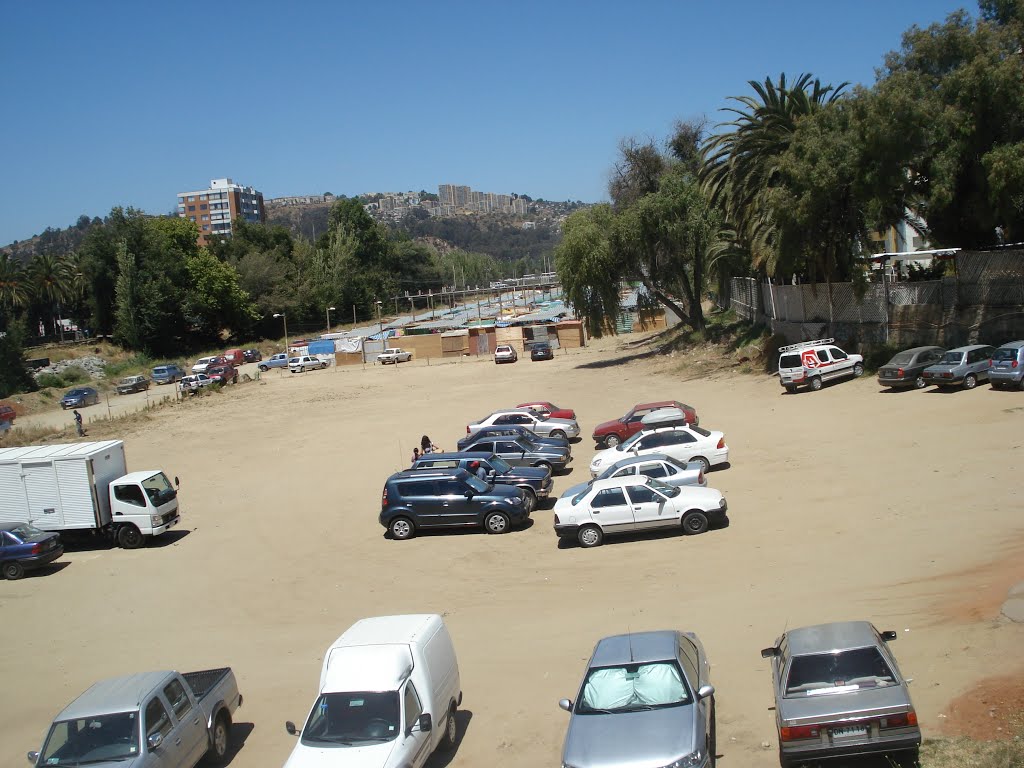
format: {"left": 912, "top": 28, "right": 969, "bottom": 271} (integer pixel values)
{"left": 0, "top": 341, "right": 1024, "bottom": 768}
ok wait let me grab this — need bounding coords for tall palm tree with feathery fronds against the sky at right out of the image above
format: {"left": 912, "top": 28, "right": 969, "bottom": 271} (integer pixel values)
{"left": 700, "top": 73, "right": 848, "bottom": 274}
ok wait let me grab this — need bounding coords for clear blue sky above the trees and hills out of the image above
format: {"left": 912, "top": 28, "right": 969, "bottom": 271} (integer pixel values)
{"left": 0, "top": 0, "right": 976, "bottom": 244}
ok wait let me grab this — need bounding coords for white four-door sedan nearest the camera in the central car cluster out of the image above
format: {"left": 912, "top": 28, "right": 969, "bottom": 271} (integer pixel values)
{"left": 554, "top": 475, "right": 729, "bottom": 547}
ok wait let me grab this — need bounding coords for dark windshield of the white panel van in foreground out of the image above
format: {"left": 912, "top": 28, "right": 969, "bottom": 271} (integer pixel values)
{"left": 302, "top": 691, "right": 400, "bottom": 748}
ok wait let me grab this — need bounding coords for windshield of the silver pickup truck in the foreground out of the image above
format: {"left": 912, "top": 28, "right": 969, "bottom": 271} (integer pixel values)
{"left": 39, "top": 712, "right": 139, "bottom": 765}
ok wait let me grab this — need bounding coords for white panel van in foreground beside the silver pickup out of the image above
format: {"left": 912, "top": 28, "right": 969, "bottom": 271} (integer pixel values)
{"left": 285, "top": 613, "right": 462, "bottom": 768}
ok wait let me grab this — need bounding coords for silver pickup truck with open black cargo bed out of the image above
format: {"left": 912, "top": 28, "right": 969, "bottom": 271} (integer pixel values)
{"left": 29, "top": 667, "right": 242, "bottom": 768}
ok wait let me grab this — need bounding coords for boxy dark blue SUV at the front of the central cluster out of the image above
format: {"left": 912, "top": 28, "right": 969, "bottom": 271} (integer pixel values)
{"left": 380, "top": 469, "right": 529, "bottom": 540}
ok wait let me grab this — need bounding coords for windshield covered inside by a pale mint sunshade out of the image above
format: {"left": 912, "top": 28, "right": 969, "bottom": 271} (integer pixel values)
{"left": 575, "top": 662, "right": 690, "bottom": 715}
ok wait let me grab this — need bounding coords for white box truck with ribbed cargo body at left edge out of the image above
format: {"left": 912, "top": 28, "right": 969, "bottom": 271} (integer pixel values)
{"left": 0, "top": 440, "right": 180, "bottom": 549}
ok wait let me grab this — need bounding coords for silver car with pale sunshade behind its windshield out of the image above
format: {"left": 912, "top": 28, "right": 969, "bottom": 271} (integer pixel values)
{"left": 558, "top": 630, "right": 715, "bottom": 768}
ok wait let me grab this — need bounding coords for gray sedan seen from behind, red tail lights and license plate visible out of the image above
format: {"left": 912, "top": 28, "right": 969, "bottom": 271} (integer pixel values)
{"left": 761, "top": 622, "right": 921, "bottom": 768}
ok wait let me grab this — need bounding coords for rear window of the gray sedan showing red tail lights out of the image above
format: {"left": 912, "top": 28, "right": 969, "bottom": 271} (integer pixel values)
{"left": 785, "top": 647, "right": 898, "bottom": 697}
